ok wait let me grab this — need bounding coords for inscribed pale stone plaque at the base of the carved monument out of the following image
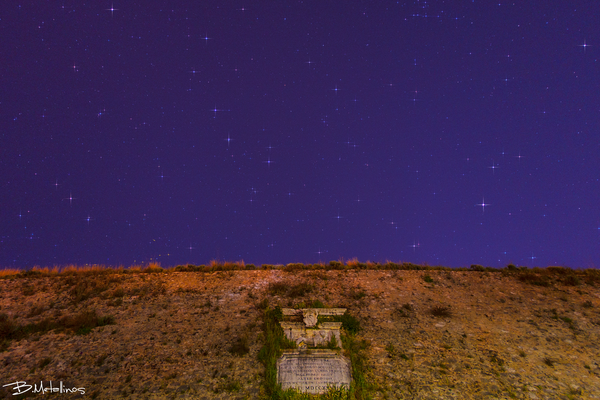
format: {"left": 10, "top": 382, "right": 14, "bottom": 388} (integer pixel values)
{"left": 277, "top": 350, "right": 352, "bottom": 394}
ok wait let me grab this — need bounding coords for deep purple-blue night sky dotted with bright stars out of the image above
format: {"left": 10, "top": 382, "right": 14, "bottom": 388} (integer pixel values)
{"left": 0, "top": 0, "right": 600, "bottom": 268}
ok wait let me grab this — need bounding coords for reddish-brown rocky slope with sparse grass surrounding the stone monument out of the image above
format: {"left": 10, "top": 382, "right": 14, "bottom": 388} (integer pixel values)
{"left": 0, "top": 270, "right": 600, "bottom": 399}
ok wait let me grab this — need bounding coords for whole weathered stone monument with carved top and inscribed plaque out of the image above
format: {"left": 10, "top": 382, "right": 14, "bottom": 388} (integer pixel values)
{"left": 277, "top": 308, "right": 352, "bottom": 394}
